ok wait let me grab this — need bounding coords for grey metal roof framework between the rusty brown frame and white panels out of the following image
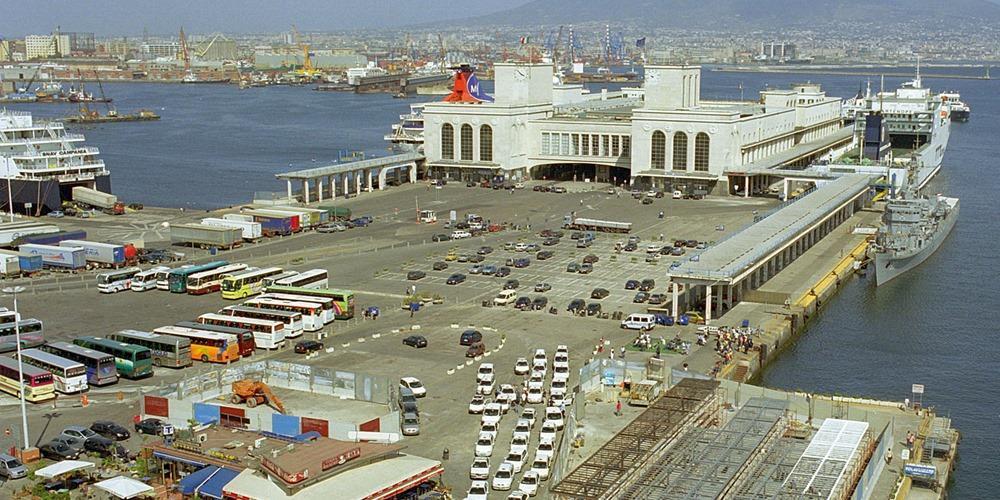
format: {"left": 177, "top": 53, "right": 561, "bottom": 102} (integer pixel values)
{"left": 618, "top": 398, "right": 786, "bottom": 500}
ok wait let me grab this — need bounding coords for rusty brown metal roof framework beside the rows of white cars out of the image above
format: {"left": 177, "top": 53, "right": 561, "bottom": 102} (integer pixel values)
{"left": 551, "top": 379, "right": 719, "bottom": 499}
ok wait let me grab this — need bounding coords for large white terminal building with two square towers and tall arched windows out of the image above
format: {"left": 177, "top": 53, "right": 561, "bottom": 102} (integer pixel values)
{"left": 423, "top": 63, "right": 852, "bottom": 196}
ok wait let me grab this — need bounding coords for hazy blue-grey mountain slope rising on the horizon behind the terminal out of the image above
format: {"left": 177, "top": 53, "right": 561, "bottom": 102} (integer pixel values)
{"left": 468, "top": 0, "right": 1000, "bottom": 29}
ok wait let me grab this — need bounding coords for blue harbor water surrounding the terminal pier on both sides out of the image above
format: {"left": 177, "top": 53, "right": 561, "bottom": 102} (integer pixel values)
{"left": 9, "top": 68, "right": 1000, "bottom": 499}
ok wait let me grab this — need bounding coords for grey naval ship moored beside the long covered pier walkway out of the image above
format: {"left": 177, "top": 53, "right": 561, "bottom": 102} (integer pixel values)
{"left": 875, "top": 190, "right": 959, "bottom": 286}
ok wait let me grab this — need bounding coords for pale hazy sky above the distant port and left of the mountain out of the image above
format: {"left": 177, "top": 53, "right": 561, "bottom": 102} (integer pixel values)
{"left": 0, "top": 0, "right": 528, "bottom": 38}
